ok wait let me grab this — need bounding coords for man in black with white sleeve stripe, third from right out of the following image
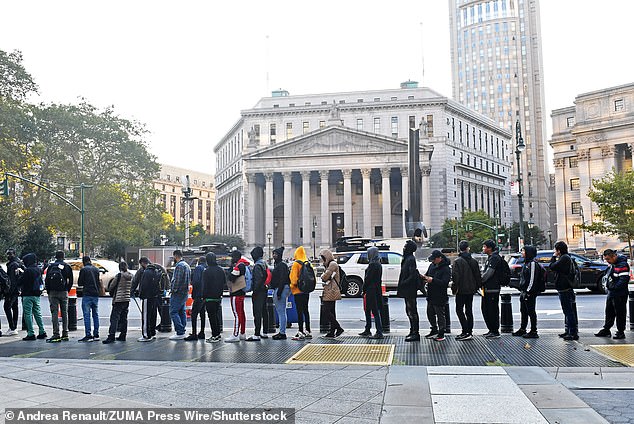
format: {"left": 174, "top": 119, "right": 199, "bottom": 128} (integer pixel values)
{"left": 513, "top": 246, "right": 544, "bottom": 339}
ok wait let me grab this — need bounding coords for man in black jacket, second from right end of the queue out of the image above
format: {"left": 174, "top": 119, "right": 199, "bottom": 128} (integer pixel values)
{"left": 549, "top": 240, "right": 579, "bottom": 341}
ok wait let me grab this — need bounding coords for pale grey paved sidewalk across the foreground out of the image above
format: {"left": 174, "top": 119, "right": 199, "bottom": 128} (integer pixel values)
{"left": 0, "top": 358, "right": 634, "bottom": 424}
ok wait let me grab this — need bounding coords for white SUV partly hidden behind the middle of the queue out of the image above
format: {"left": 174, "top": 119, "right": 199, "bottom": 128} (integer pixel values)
{"left": 334, "top": 250, "right": 429, "bottom": 297}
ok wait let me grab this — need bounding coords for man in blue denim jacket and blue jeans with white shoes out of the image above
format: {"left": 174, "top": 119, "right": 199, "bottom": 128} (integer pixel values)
{"left": 169, "top": 249, "right": 191, "bottom": 340}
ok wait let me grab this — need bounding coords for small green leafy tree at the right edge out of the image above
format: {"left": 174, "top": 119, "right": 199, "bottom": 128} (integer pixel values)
{"left": 582, "top": 168, "right": 634, "bottom": 257}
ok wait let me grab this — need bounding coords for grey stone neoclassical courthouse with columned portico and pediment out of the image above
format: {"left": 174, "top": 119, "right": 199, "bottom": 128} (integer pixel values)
{"left": 214, "top": 81, "right": 512, "bottom": 254}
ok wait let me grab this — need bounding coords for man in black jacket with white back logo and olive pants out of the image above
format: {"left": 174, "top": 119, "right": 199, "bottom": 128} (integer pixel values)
{"left": 44, "top": 250, "right": 73, "bottom": 343}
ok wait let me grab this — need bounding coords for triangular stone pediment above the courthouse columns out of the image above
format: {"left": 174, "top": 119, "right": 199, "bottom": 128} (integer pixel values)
{"left": 245, "top": 125, "right": 407, "bottom": 159}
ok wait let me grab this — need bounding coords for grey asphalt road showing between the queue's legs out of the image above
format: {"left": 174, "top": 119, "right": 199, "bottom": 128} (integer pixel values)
{"left": 0, "top": 290, "right": 616, "bottom": 334}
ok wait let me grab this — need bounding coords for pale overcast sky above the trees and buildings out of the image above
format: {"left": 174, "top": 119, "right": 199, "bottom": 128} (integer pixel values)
{"left": 0, "top": 0, "right": 634, "bottom": 172}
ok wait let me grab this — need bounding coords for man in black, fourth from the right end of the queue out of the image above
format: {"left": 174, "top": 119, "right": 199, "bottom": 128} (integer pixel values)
{"left": 481, "top": 240, "right": 504, "bottom": 339}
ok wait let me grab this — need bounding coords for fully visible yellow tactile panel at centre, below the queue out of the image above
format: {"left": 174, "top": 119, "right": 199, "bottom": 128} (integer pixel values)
{"left": 286, "top": 344, "right": 394, "bottom": 365}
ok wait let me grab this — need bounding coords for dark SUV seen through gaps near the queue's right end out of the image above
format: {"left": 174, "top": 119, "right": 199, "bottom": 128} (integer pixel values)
{"left": 507, "top": 250, "right": 608, "bottom": 293}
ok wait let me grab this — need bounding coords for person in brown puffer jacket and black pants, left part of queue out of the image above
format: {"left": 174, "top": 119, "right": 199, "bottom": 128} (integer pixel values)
{"left": 103, "top": 261, "right": 132, "bottom": 344}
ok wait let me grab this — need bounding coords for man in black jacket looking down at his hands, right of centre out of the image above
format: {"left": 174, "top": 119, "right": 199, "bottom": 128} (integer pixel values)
{"left": 423, "top": 250, "right": 451, "bottom": 342}
